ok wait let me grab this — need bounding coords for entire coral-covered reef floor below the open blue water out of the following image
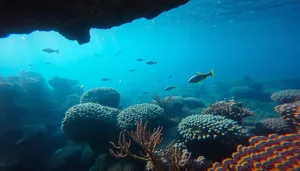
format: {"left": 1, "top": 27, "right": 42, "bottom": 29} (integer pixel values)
{"left": 0, "top": 72, "right": 300, "bottom": 171}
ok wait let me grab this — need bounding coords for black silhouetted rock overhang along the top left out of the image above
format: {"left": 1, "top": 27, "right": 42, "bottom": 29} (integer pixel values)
{"left": 0, "top": 0, "right": 189, "bottom": 44}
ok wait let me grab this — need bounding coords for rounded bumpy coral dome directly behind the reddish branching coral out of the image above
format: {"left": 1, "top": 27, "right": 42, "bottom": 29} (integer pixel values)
{"left": 117, "top": 103, "right": 164, "bottom": 129}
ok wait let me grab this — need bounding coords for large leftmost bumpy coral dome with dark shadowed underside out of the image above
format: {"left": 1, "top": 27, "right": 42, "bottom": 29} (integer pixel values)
{"left": 61, "top": 103, "right": 119, "bottom": 142}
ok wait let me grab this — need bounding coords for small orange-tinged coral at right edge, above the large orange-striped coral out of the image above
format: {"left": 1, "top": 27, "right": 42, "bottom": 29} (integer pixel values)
{"left": 274, "top": 101, "right": 300, "bottom": 133}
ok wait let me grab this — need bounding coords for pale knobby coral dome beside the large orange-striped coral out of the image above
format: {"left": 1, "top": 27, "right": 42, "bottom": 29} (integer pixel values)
{"left": 178, "top": 115, "right": 249, "bottom": 142}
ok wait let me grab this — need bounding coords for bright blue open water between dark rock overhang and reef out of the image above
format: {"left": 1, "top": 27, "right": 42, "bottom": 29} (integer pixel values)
{"left": 0, "top": 0, "right": 300, "bottom": 170}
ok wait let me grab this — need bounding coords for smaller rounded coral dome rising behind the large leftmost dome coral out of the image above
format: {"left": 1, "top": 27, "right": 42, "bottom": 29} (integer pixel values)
{"left": 80, "top": 87, "right": 121, "bottom": 108}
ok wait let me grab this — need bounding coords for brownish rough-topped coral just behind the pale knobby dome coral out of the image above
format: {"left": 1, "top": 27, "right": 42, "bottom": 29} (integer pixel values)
{"left": 201, "top": 101, "right": 254, "bottom": 123}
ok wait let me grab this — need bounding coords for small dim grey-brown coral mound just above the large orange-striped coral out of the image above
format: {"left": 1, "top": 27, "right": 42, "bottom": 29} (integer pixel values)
{"left": 255, "top": 118, "right": 291, "bottom": 135}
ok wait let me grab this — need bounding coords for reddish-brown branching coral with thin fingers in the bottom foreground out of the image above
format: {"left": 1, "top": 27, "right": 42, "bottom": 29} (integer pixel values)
{"left": 110, "top": 121, "right": 207, "bottom": 171}
